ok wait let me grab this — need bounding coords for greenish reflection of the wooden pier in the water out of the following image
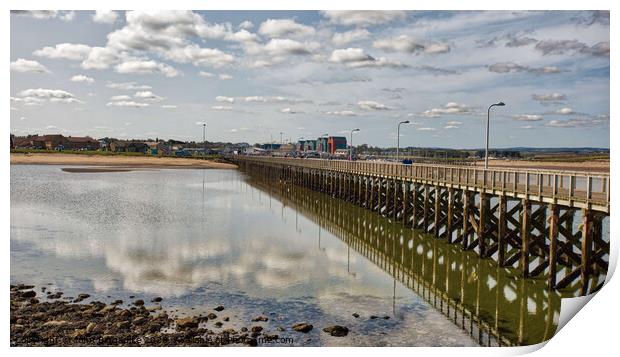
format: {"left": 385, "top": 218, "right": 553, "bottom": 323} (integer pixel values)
{"left": 248, "top": 177, "right": 560, "bottom": 346}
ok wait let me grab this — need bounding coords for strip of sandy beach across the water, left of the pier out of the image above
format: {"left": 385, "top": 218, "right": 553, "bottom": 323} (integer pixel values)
{"left": 11, "top": 153, "right": 236, "bottom": 169}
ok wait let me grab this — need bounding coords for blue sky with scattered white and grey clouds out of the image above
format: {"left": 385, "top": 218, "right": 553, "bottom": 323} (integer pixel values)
{"left": 11, "top": 11, "right": 610, "bottom": 148}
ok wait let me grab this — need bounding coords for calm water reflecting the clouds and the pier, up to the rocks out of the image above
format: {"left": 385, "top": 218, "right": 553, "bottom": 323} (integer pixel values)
{"left": 11, "top": 165, "right": 560, "bottom": 346}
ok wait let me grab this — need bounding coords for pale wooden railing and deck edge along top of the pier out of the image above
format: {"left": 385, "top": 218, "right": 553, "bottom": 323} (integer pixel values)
{"left": 229, "top": 156, "right": 610, "bottom": 213}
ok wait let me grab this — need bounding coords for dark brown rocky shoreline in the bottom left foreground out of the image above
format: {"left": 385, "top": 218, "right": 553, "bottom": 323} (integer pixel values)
{"left": 10, "top": 284, "right": 349, "bottom": 347}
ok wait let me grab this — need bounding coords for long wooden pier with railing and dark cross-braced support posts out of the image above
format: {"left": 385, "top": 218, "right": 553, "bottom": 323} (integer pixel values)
{"left": 227, "top": 155, "right": 610, "bottom": 295}
